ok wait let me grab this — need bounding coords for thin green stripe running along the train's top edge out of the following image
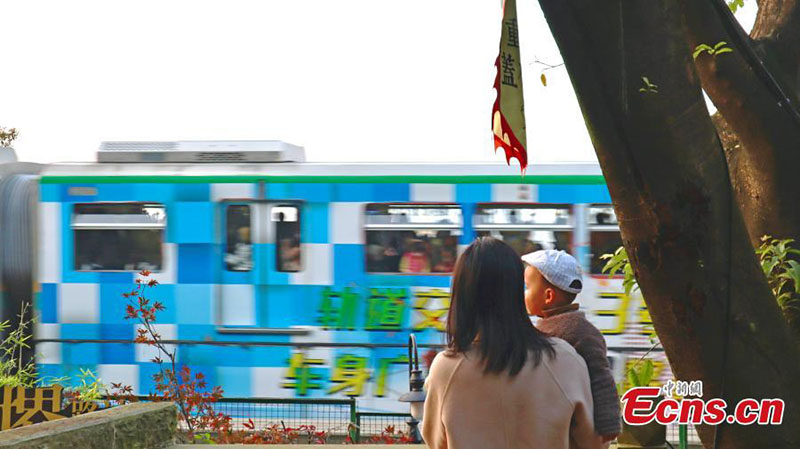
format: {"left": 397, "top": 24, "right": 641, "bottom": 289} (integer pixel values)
{"left": 41, "top": 175, "right": 605, "bottom": 185}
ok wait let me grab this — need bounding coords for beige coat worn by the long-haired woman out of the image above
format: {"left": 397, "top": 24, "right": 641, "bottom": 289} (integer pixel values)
{"left": 422, "top": 338, "right": 605, "bottom": 449}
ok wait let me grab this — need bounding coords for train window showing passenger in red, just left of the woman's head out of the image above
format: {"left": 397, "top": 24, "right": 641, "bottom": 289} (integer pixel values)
{"left": 364, "top": 204, "right": 462, "bottom": 273}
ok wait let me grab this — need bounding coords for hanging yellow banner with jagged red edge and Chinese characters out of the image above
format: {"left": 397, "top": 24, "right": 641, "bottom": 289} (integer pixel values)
{"left": 492, "top": 0, "right": 528, "bottom": 174}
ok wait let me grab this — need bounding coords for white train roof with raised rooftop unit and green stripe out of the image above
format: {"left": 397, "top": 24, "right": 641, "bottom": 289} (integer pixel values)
{"left": 34, "top": 140, "right": 604, "bottom": 184}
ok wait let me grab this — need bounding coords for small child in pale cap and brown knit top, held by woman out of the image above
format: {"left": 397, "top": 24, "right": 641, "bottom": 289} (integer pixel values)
{"left": 522, "top": 249, "right": 620, "bottom": 442}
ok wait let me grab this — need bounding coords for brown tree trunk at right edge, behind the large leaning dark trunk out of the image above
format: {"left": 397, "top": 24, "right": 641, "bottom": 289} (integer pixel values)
{"left": 679, "top": 0, "right": 800, "bottom": 246}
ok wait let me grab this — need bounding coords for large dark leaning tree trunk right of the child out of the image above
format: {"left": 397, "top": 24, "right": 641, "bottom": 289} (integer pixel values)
{"left": 540, "top": 0, "right": 800, "bottom": 449}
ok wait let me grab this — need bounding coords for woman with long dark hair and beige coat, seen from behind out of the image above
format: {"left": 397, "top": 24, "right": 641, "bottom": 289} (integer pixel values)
{"left": 422, "top": 237, "right": 604, "bottom": 449}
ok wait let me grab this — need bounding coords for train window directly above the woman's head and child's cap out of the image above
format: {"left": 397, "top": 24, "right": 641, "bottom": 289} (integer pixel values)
{"left": 473, "top": 204, "right": 573, "bottom": 255}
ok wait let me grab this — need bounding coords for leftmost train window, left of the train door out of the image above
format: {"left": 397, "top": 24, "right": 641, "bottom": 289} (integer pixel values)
{"left": 72, "top": 203, "right": 167, "bottom": 271}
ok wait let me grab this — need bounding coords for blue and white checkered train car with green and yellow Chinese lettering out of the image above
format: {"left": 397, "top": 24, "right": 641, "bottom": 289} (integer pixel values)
{"left": 26, "top": 141, "right": 669, "bottom": 411}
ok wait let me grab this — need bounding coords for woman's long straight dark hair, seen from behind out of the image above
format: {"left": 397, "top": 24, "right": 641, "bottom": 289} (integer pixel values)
{"left": 447, "top": 237, "right": 555, "bottom": 376}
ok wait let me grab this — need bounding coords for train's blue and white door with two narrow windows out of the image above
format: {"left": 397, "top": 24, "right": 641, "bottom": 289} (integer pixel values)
{"left": 217, "top": 200, "right": 303, "bottom": 330}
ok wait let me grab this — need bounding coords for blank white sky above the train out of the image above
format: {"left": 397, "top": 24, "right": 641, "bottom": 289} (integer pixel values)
{"left": 0, "top": 0, "right": 755, "bottom": 164}
